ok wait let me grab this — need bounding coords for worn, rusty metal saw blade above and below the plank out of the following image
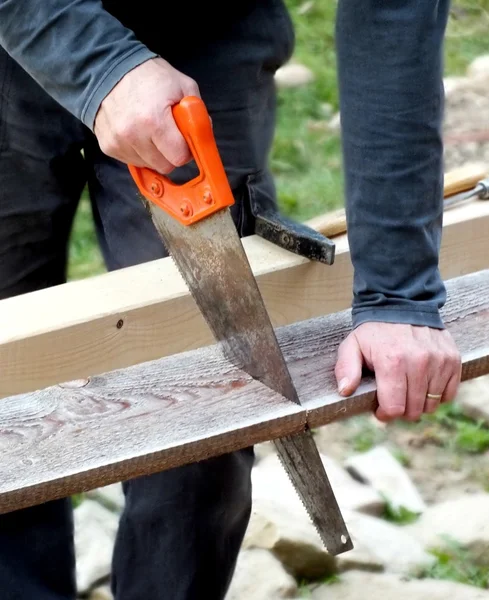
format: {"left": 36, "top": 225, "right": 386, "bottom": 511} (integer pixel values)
{"left": 142, "top": 199, "right": 352, "bottom": 555}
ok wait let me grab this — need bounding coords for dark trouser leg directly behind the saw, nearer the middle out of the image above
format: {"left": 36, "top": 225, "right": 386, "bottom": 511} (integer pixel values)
{"left": 82, "top": 0, "right": 292, "bottom": 600}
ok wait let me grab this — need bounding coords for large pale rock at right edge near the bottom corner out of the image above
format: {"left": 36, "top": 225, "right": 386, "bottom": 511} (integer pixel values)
{"left": 407, "top": 494, "right": 489, "bottom": 565}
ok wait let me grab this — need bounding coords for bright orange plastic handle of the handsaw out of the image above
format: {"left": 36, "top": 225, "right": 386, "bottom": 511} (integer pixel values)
{"left": 128, "top": 96, "right": 234, "bottom": 225}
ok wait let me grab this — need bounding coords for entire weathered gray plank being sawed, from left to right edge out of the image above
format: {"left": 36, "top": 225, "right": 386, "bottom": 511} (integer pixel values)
{"left": 0, "top": 270, "right": 489, "bottom": 512}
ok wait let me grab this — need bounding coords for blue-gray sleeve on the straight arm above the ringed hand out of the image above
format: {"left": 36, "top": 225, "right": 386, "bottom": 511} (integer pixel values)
{"left": 337, "top": 0, "right": 449, "bottom": 328}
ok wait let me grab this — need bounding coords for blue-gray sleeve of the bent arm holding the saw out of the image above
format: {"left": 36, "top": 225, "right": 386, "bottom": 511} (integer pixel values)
{"left": 0, "top": 0, "right": 155, "bottom": 129}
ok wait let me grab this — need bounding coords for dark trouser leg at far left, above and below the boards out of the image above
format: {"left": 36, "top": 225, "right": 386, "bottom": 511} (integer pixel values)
{"left": 0, "top": 48, "right": 84, "bottom": 600}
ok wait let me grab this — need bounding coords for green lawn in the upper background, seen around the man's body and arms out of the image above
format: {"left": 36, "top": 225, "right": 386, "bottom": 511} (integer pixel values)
{"left": 69, "top": 0, "right": 489, "bottom": 279}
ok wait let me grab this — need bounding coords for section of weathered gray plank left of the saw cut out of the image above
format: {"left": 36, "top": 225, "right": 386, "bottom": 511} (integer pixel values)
{"left": 0, "top": 346, "right": 306, "bottom": 512}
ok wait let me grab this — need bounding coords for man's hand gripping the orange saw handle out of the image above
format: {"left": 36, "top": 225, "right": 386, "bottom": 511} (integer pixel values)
{"left": 94, "top": 58, "right": 200, "bottom": 174}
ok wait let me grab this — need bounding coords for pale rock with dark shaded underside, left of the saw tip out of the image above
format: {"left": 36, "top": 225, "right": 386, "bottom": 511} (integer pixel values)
{"left": 243, "top": 498, "right": 335, "bottom": 578}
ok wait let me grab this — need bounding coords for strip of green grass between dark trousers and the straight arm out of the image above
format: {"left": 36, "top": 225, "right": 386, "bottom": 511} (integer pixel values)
{"left": 271, "top": 0, "right": 343, "bottom": 219}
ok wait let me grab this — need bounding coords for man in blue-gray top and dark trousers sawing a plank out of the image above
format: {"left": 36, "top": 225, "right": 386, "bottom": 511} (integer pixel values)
{"left": 0, "top": 0, "right": 460, "bottom": 600}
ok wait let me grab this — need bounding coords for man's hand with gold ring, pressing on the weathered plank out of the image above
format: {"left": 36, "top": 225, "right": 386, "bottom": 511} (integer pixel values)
{"left": 335, "top": 322, "right": 462, "bottom": 422}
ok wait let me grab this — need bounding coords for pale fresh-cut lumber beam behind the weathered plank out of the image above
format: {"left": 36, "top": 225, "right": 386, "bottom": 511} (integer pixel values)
{"left": 0, "top": 202, "right": 489, "bottom": 397}
